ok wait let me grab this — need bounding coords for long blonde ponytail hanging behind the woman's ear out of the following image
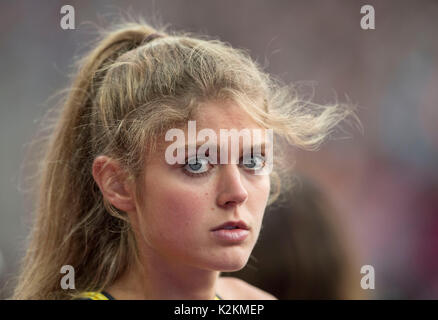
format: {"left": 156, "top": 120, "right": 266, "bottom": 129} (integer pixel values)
{"left": 13, "top": 24, "right": 164, "bottom": 299}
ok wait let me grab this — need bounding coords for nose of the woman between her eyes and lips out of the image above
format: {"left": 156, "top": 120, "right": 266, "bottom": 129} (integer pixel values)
{"left": 217, "top": 164, "right": 248, "bottom": 208}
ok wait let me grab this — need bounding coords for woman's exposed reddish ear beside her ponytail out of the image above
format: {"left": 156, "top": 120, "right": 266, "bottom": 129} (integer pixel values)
{"left": 92, "top": 155, "right": 136, "bottom": 212}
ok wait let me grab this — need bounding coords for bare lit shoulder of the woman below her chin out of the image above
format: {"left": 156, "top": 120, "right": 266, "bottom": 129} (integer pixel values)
{"left": 219, "top": 277, "right": 278, "bottom": 300}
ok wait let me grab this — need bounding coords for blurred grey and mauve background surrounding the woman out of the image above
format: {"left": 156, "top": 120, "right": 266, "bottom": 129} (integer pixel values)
{"left": 0, "top": 0, "right": 438, "bottom": 299}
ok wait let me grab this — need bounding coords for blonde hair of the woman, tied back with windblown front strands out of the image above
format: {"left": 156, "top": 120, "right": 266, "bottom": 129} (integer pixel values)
{"left": 13, "top": 17, "right": 362, "bottom": 299}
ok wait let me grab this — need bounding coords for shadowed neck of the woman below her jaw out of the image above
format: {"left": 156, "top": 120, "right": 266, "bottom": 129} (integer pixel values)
{"left": 107, "top": 242, "right": 220, "bottom": 300}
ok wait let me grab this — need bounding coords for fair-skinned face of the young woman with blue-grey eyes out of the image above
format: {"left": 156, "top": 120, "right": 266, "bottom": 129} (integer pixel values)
{"left": 133, "top": 102, "right": 270, "bottom": 271}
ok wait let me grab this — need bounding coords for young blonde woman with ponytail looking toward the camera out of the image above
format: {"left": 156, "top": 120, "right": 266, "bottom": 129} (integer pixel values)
{"left": 14, "top": 22, "right": 355, "bottom": 299}
